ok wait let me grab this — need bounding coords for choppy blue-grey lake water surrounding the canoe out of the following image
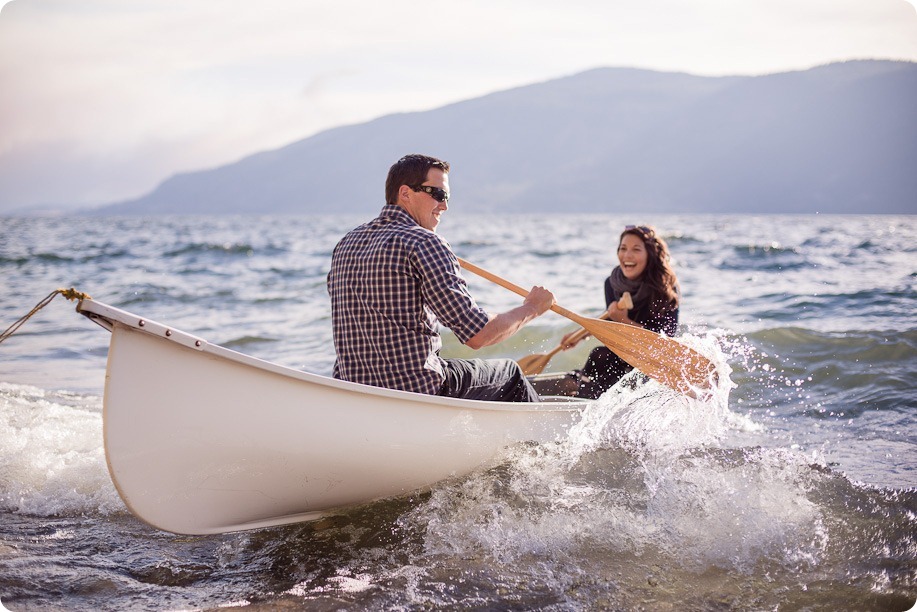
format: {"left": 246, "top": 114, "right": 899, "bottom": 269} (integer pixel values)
{"left": 0, "top": 211, "right": 917, "bottom": 610}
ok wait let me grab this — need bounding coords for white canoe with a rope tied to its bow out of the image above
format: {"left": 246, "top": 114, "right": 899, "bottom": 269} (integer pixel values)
{"left": 77, "top": 299, "right": 586, "bottom": 534}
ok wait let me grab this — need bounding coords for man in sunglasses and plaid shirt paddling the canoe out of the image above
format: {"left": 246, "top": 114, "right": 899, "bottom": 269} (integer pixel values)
{"left": 328, "top": 154, "right": 554, "bottom": 402}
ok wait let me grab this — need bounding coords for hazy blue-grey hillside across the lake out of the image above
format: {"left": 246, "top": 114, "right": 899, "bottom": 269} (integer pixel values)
{"left": 93, "top": 61, "right": 917, "bottom": 214}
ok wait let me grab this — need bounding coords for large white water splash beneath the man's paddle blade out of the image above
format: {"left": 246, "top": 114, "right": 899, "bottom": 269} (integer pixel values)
{"left": 405, "top": 335, "right": 827, "bottom": 572}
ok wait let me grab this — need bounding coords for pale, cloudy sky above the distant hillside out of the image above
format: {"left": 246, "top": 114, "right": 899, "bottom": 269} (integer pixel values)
{"left": 0, "top": 0, "right": 917, "bottom": 214}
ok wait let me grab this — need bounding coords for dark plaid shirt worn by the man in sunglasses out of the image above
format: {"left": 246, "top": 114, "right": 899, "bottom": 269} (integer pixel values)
{"left": 328, "top": 204, "right": 489, "bottom": 394}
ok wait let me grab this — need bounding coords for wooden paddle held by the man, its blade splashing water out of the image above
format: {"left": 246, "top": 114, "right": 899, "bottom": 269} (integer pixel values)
{"left": 458, "top": 258, "right": 716, "bottom": 395}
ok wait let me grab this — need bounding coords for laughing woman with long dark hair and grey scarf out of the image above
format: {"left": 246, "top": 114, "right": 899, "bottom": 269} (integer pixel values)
{"left": 561, "top": 225, "right": 679, "bottom": 399}
